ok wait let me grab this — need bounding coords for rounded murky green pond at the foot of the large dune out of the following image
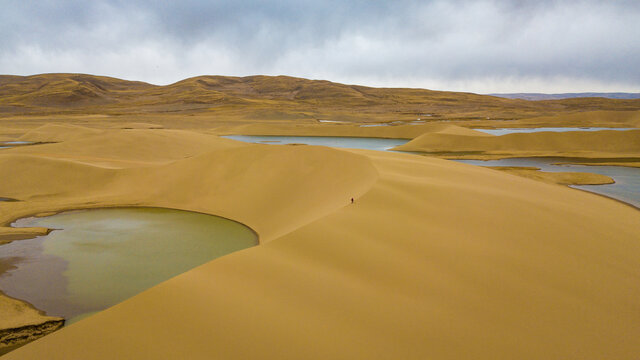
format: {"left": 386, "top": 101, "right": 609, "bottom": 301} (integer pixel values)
{"left": 0, "top": 208, "right": 258, "bottom": 324}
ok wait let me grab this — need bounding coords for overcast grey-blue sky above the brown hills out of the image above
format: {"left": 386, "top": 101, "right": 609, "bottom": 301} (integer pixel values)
{"left": 0, "top": 0, "right": 640, "bottom": 93}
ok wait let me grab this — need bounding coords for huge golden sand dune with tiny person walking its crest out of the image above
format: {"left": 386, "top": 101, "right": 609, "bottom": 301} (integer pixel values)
{"left": 0, "top": 128, "right": 640, "bottom": 359}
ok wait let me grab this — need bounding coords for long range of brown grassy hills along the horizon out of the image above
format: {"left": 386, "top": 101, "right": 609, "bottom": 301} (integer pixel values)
{"left": 0, "top": 74, "right": 640, "bottom": 122}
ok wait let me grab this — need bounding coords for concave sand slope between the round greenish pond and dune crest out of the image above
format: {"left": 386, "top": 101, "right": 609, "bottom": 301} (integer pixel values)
{"left": 0, "top": 130, "right": 377, "bottom": 241}
